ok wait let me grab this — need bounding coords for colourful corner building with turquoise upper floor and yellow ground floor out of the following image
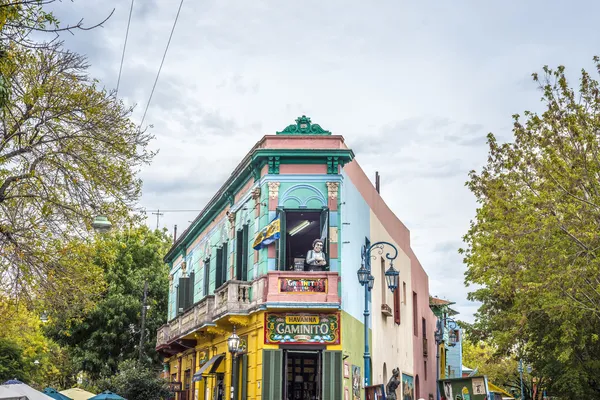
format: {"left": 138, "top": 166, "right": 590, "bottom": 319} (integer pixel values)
{"left": 157, "top": 116, "right": 435, "bottom": 400}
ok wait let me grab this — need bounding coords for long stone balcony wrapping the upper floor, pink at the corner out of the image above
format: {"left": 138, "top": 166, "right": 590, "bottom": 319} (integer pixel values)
{"left": 156, "top": 271, "right": 340, "bottom": 353}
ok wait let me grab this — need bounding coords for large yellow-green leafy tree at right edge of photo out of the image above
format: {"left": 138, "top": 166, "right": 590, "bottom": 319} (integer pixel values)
{"left": 461, "top": 58, "right": 600, "bottom": 399}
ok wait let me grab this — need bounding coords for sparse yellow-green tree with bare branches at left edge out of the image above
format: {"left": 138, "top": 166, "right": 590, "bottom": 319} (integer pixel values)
{"left": 0, "top": 41, "right": 153, "bottom": 312}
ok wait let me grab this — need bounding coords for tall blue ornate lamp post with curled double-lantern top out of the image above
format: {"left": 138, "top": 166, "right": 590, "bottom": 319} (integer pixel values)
{"left": 356, "top": 242, "right": 400, "bottom": 386}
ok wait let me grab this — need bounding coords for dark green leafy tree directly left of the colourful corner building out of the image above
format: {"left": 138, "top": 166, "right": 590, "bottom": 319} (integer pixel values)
{"left": 48, "top": 226, "right": 171, "bottom": 379}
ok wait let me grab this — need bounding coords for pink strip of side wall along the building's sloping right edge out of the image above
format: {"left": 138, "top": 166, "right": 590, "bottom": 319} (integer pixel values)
{"left": 344, "top": 161, "right": 436, "bottom": 399}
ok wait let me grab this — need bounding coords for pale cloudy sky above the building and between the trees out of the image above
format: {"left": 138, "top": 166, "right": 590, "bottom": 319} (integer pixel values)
{"left": 52, "top": 0, "right": 600, "bottom": 322}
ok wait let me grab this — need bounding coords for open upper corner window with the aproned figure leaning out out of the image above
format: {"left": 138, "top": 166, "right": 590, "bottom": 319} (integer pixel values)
{"left": 277, "top": 208, "right": 329, "bottom": 271}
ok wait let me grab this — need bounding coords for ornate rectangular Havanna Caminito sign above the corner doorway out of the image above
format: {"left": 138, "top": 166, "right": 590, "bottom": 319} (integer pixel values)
{"left": 265, "top": 313, "right": 340, "bottom": 344}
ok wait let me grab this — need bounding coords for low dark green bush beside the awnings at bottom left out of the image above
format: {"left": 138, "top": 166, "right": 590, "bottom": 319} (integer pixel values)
{"left": 99, "top": 360, "right": 171, "bottom": 400}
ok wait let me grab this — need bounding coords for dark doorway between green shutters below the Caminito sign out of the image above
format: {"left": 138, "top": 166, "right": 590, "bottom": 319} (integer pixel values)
{"left": 283, "top": 350, "right": 322, "bottom": 400}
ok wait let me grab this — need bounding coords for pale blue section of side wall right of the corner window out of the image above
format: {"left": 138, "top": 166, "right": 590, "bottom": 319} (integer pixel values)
{"left": 339, "top": 172, "right": 371, "bottom": 321}
